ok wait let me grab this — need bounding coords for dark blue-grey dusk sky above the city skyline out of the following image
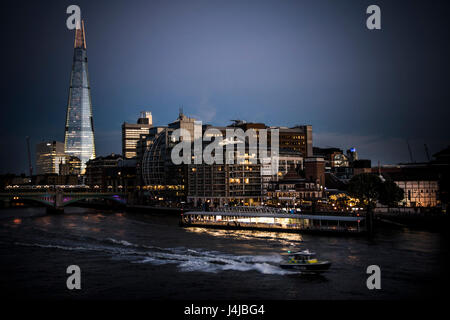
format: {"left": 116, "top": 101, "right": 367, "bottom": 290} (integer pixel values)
{"left": 0, "top": 0, "right": 450, "bottom": 173}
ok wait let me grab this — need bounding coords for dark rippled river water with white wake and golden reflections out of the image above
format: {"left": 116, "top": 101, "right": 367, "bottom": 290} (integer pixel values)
{"left": 0, "top": 207, "right": 448, "bottom": 300}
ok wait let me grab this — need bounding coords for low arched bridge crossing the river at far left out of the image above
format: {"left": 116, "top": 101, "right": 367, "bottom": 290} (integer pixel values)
{"left": 0, "top": 186, "right": 127, "bottom": 210}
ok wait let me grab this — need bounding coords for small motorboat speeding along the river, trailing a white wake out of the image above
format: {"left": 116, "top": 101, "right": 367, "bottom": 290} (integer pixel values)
{"left": 280, "top": 250, "right": 331, "bottom": 273}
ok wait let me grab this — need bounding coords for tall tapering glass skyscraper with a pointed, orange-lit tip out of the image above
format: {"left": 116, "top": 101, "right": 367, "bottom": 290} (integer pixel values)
{"left": 64, "top": 22, "right": 95, "bottom": 174}
